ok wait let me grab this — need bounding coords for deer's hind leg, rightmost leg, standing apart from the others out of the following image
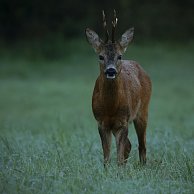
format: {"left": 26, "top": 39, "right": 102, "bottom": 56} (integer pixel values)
{"left": 134, "top": 111, "right": 148, "bottom": 164}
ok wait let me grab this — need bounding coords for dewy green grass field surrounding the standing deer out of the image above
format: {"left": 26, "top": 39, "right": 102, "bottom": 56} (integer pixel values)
{"left": 0, "top": 42, "right": 194, "bottom": 194}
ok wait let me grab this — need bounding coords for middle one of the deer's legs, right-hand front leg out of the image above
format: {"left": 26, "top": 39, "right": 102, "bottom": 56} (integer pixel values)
{"left": 114, "top": 127, "right": 131, "bottom": 165}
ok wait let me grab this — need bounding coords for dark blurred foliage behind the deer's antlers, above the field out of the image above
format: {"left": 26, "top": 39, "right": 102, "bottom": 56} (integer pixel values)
{"left": 0, "top": 0, "right": 194, "bottom": 42}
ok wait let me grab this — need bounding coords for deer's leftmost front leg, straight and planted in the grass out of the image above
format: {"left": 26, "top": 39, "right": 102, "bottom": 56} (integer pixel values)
{"left": 98, "top": 127, "right": 112, "bottom": 166}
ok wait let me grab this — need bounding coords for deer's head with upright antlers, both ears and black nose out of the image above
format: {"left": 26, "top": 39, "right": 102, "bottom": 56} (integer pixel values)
{"left": 86, "top": 10, "right": 134, "bottom": 79}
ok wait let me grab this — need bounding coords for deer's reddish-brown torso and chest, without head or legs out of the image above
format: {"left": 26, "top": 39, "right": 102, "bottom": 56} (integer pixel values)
{"left": 92, "top": 60, "right": 151, "bottom": 125}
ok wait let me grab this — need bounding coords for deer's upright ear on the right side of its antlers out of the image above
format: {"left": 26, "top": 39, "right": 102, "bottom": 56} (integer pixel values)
{"left": 119, "top": 28, "right": 134, "bottom": 52}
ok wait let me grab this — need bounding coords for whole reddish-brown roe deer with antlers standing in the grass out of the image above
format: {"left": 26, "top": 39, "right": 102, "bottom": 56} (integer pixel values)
{"left": 86, "top": 11, "right": 151, "bottom": 165}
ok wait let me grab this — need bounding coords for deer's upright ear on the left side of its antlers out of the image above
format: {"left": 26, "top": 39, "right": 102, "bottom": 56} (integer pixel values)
{"left": 86, "top": 28, "right": 102, "bottom": 53}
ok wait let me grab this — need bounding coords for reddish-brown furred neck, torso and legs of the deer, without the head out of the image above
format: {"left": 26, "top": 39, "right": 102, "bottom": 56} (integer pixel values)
{"left": 92, "top": 60, "right": 151, "bottom": 164}
